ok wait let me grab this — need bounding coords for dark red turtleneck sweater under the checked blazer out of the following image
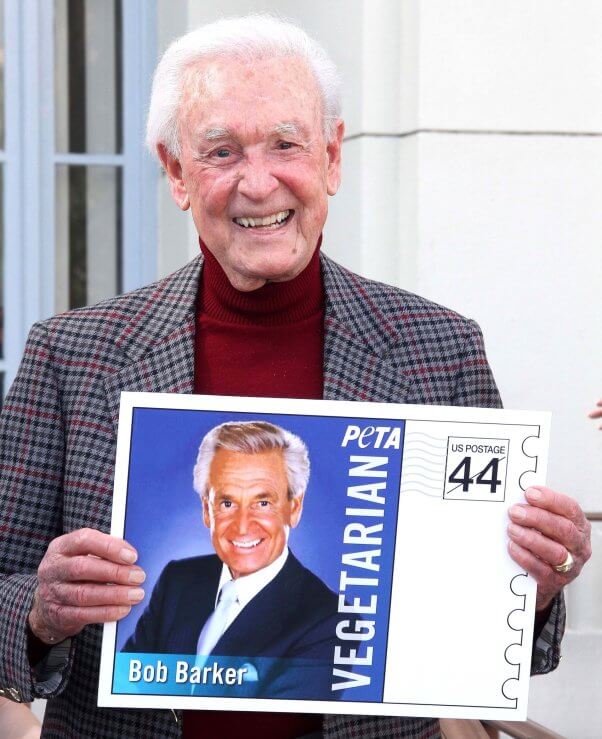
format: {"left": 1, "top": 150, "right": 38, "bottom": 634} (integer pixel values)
{"left": 184, "top": 243, "right": 324, "bottom": 739}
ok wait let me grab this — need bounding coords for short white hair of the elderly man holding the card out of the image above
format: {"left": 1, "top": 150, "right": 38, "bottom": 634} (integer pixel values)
{"left": 146, "top": 14, "right": 341, "bottom": 157}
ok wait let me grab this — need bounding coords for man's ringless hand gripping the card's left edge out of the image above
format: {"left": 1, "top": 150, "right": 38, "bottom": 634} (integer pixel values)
{"left": 29, "top": 529, "right": 146, "bottom": 644}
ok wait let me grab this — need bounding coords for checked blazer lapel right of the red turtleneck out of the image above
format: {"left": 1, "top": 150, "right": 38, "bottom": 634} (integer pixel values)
{"left": 321, "top": 255, "right": 409, "bottom": 403}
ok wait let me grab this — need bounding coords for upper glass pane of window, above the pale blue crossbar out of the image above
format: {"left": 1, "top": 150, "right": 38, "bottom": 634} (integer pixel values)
{"left": 54, "top": 0, "right": 122, "bottom": 154}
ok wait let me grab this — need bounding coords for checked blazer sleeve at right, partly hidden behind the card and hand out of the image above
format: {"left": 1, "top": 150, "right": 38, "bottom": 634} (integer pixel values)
{"left": 453, "top": 321, "right": 566, "bottom": 675}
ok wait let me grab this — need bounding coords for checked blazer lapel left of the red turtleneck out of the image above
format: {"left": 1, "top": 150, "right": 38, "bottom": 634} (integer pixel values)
{"left": 104, "top": 255, "right": 203, "bottom": 428}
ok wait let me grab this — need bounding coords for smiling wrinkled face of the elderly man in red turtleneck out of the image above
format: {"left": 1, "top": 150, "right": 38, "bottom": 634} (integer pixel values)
{"left": 159, "top": 57, "right": 343, "bottom": 290}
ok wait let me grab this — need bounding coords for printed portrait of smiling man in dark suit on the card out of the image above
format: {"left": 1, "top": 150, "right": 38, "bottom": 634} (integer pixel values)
{"left": 122, "top": 421, "right": 357, "bottom": 700}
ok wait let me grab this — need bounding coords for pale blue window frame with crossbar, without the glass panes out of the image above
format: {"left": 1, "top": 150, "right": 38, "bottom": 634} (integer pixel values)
{"left": 0, "top": 0, "right": 159, "bottom": 392}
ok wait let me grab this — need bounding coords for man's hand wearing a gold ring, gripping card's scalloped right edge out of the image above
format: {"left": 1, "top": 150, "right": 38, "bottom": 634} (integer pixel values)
{"left": 508, "top": 487, "right": 592, "bottom": 611}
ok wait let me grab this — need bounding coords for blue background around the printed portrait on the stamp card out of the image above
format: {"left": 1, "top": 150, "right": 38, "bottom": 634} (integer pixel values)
{"left": 117, "top": 408, "right": 404, "bottom": 701}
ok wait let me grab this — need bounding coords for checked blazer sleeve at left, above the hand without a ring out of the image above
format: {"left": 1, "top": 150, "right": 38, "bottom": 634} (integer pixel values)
{"left": 0, "top": 323, "right": 73, "bottom": 701}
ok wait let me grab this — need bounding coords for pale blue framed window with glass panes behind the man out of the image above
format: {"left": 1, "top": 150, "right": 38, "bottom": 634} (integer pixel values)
{"left": 0, "top": 0, "right": 158, "bottom": 397}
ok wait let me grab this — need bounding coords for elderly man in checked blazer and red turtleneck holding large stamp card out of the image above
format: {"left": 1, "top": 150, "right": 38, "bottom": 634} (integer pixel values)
{"left": 0, "top": 11, "right": 590, "bottom": 737}
